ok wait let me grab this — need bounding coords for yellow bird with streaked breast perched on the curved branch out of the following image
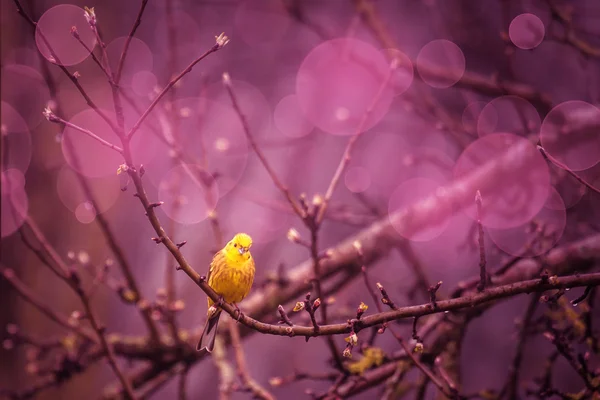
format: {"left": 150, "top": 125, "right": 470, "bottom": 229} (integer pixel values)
{"left": 196, "top": 233, "right": 255, "bottom": 353}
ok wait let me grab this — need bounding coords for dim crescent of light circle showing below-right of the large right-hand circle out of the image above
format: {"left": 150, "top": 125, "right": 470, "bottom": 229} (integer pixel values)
{"left": 487, "top": 187, "right": 567, "bottom": 256}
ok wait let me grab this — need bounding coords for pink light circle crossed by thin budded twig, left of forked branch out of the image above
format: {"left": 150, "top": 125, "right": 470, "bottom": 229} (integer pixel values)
{"left": 61, "top": 109, "right": 123, "bottom": 178}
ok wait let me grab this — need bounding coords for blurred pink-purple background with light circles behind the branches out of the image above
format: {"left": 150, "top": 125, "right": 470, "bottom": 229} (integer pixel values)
{"left": 0, "top": 0, "right": 600, "bottom": 399}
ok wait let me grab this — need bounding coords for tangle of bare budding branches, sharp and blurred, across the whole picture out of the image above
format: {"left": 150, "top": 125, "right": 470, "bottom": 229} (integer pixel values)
{"left": 0, "top": 0, "right": 600, "bottom": 399}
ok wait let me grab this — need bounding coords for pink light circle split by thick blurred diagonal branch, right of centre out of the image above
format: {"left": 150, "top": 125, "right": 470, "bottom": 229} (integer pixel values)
{"left": 388, "top": 178, "right": 449, "bottom": 242}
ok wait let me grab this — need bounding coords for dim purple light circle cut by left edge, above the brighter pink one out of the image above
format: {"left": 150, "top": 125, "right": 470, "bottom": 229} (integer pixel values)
{"left": 0, "top": 101, "right": 31, "bottom": 173}
